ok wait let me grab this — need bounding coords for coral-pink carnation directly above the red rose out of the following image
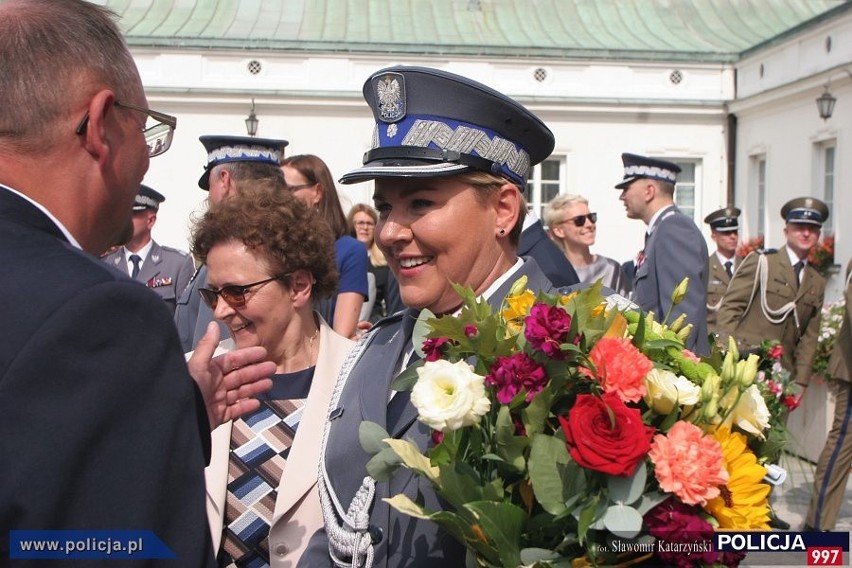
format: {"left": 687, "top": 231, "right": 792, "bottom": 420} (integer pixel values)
{"left": 581, "top": 337, "right": 654, "bottom": 402}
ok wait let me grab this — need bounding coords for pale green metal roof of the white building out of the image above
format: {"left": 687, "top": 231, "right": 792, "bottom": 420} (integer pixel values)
{"left": 100, "top": 0, "right": 850, "bottom": 61}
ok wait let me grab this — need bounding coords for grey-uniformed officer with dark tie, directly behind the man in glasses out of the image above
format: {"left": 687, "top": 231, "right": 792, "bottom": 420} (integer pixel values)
{"left": 101, "top": 184, "right": 195, "bottom": 314}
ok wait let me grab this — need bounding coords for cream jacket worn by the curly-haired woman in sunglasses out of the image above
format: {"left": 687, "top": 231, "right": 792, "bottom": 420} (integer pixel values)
{"left": 204, "top": 318, "right": 355, "bottom": 568}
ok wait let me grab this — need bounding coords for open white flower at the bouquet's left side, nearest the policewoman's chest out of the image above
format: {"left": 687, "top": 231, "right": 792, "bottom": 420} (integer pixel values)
{"left": 411, "top": 359, "right": 491, "bottom": 432}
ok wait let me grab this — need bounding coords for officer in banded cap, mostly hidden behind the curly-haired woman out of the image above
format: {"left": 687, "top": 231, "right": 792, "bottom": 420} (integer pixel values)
{"left": 175, "top": 135, "right": 288, "bottom": 351}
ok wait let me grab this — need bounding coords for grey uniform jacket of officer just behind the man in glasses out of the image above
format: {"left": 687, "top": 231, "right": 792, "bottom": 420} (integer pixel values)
{"left": 101, "top": 241, "right": 195, "bottom": 314}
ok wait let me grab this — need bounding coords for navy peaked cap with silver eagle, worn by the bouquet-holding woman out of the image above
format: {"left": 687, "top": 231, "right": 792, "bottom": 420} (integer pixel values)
{"left": 340, "top": 66, "right": 554, "bottom": 188}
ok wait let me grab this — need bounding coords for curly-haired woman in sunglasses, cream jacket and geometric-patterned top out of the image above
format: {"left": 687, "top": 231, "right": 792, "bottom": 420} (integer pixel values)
{"left": 192, "top": 186, "right": 352, "bottom": 566}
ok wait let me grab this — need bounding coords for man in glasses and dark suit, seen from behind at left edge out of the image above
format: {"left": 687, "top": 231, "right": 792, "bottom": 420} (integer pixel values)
{"left": 0, "top": 0, "right": 275, "bottom": 567}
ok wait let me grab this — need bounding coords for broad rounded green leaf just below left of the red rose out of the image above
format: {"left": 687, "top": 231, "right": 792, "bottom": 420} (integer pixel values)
{"left": 529, "top": 434, "right": 576, "bottom": 515}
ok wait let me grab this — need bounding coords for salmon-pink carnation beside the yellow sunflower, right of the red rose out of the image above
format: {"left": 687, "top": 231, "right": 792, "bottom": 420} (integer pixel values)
{"left": 648, "top": 420, "right": 728, "bottom": 505}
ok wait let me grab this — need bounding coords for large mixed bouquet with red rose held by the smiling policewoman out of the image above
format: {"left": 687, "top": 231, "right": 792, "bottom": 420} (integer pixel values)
{"left": 360, "top": 279, "right": 770, "bottom": 568}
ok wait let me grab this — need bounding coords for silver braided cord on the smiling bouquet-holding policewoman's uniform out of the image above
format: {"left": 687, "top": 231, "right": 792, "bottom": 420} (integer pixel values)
{"left": 317, "top": 329, "right": 376, "bottom": 568}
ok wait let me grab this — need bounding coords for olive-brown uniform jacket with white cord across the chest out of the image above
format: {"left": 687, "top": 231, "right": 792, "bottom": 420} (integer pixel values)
{"left": 716, "top": 249, "right": 825, "bottom": 384}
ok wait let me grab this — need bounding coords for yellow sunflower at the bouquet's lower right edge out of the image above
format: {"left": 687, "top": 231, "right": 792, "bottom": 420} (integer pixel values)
{"left": 704, "top": 428, "right": 770, "bottom": 531}
